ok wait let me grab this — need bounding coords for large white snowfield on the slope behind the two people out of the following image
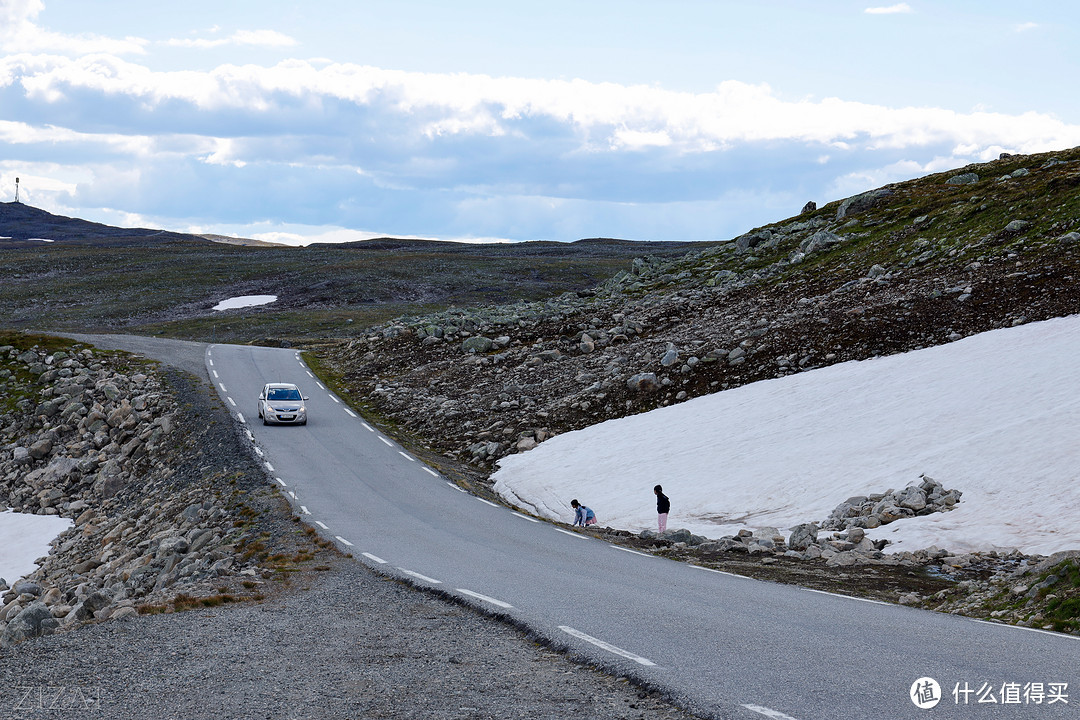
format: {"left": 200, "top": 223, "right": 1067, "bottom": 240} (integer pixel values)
{"left": 492, "top": 315, "right": 1080, "bottom": 555}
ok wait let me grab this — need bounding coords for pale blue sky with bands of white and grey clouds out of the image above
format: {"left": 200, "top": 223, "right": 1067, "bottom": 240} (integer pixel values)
{"left": 0, "top": 0, "right": 1080, "bottom": 244}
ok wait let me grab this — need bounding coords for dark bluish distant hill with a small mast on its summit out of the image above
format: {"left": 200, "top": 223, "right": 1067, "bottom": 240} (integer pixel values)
{"left": 0, "top": 203, "right": 208, "bottom": 247}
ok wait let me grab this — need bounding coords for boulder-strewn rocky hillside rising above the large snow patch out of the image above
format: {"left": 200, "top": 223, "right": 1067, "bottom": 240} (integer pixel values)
{"left": 318, "top": 149, "right": 1080, "bottom": 472}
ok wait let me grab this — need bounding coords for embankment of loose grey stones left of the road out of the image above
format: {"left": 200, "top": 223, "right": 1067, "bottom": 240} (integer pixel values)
{"left": 0, "top": 345, "right": 274, "bottom": 646}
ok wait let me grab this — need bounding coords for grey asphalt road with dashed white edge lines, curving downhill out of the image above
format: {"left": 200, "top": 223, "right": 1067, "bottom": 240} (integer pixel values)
{"left": 78, "top": 344, "right": 1080, "bottom": 720}
